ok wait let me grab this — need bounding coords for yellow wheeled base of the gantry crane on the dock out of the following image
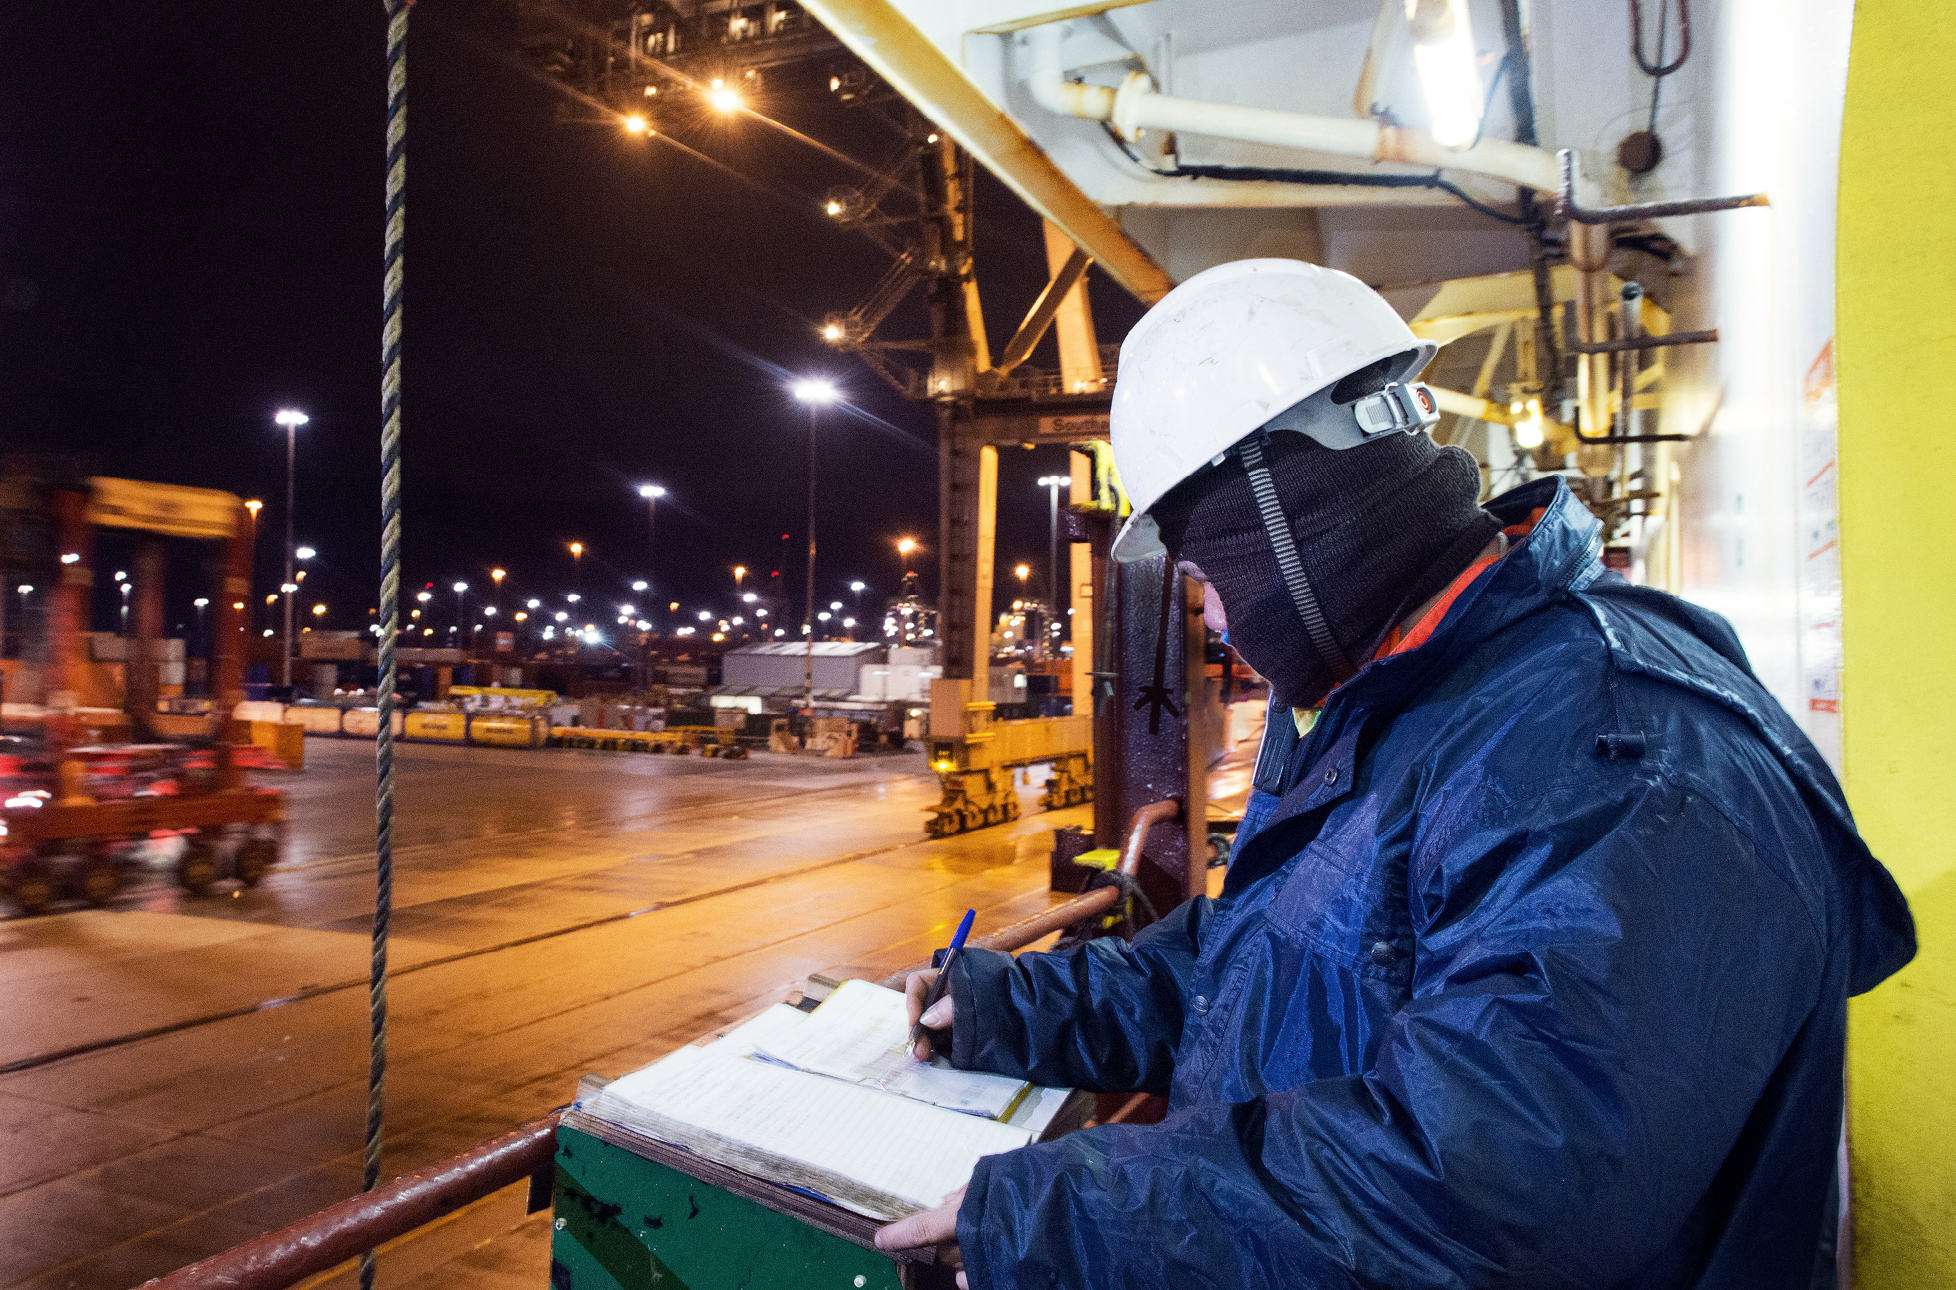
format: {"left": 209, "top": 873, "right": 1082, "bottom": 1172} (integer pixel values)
{"left": 923, "top": 680, "right": 1093, "bottom": 839}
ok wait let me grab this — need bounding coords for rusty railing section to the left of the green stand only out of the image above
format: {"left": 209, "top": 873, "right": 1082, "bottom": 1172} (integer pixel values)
{"left": 143, "top": 1116, "right": 557, "bottom": 1290}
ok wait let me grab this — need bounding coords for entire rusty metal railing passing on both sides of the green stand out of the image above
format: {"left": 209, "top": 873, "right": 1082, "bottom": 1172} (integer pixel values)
{"left": 141, "top": 801, "right": 1181, "bottom": 1290}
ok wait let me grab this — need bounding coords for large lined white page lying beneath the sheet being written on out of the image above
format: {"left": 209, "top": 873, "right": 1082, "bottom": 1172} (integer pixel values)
{"left": 585, "top": 1048, "right": 1033, "bottom": 1218}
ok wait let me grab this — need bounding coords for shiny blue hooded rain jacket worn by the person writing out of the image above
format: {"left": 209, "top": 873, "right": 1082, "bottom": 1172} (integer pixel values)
{"left": 953, "top": 481, "right": 1915, "bottom": 1290}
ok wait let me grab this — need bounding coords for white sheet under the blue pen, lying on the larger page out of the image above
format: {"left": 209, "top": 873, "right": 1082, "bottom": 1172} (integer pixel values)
{"left": 755, "top": 981, "right": 1027, "bottom": 1120}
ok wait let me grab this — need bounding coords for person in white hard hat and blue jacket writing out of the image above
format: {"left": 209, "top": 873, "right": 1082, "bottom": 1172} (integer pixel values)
{"left": 878, "top": 260, "right": 1915, "bottom": 1290}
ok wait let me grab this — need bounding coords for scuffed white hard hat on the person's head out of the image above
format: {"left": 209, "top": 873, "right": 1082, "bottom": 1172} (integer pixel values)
{"left": 1111, "top": 260, "right": 1440, "bottom": 561}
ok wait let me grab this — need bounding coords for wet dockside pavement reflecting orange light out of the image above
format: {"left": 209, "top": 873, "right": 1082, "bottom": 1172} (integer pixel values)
{"left": 0, "top": 741, "right": 1089, "bottom": 1288}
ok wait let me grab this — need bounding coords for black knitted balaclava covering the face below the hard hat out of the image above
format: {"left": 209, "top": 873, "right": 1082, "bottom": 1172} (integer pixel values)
{"left": 1150, "top": 420, "right": 1500, "bottom": 708}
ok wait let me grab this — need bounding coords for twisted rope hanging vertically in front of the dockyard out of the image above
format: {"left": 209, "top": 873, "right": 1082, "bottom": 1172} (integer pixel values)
{"left": 360, "top": 10, "right": 415, "bottom": 1290}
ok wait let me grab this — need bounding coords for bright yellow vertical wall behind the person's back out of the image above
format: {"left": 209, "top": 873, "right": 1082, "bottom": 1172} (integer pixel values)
{"left": 1839, "top": 0, "right": 1956, "bottom": 1290}
